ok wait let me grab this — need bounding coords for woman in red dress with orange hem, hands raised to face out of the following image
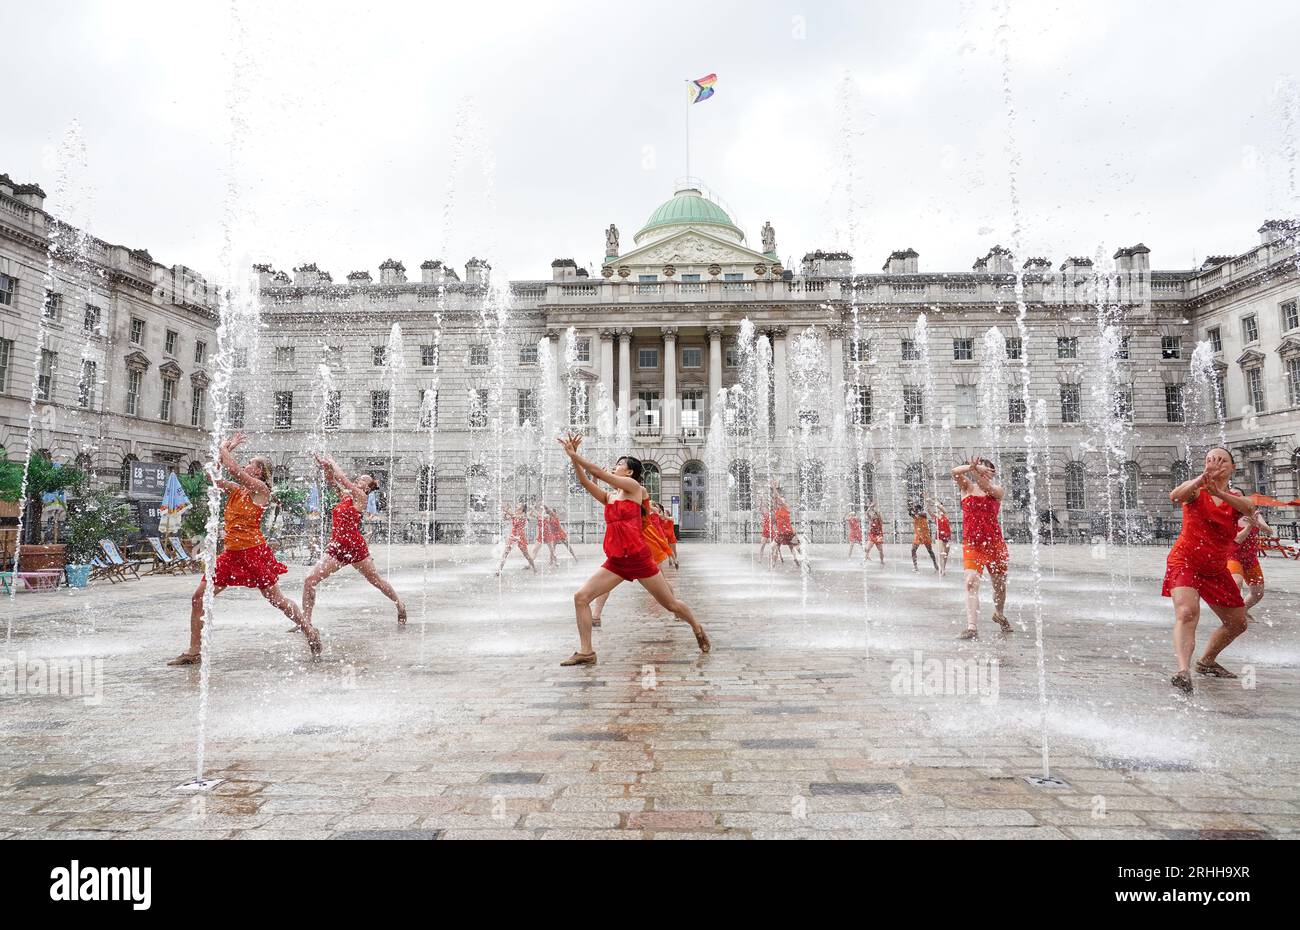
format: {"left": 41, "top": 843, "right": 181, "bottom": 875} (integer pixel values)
{"left": 953, "top": 458, "right": 1014, "bottom": 640}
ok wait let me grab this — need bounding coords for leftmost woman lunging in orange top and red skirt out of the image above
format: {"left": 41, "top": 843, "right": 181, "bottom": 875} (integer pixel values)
{"left": 168, "top": 432, "right": 309, "bottom": 666}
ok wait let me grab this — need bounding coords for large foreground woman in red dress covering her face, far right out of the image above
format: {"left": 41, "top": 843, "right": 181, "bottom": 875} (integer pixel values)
{"left": 1161, "top": 446, "right": 1255, "bottom": 695}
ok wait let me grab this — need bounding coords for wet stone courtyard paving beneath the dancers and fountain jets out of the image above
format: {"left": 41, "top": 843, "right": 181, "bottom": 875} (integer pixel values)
{"left": 0, "top": 544, "right": 1300, "bottom": 839}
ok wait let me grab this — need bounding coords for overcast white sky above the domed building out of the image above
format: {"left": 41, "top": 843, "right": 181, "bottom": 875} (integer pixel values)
{"left": 10, "top": 0, "right": 1300, "bottom": 281}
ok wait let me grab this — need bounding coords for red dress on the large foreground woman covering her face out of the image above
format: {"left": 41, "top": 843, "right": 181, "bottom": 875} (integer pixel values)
{"left": 1161, "top": 489, "right": 1245, "bottom": 607}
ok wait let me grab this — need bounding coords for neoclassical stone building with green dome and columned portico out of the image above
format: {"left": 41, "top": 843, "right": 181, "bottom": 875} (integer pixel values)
{"left": 0, "top": 170, "right": 1300, "bottom": 538}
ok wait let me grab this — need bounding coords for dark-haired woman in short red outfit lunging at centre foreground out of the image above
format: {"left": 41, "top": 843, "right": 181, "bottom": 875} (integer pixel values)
{"left": 559, "top": 433, "right": 710, "bottom": 666}
